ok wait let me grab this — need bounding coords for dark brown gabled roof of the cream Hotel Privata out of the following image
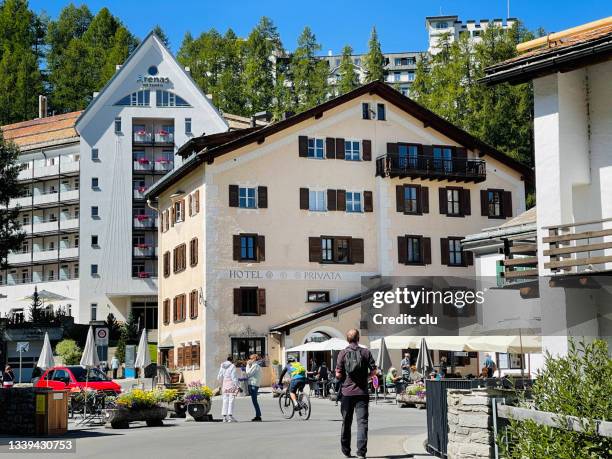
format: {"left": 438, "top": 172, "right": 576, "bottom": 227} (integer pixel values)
{"left": 147, "top": 81, "right": 533, "bottom": 199}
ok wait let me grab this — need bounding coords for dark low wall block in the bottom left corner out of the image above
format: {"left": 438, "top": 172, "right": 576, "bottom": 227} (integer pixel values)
{"left": 0, "top": 387, "right": 36, "bottom": 435}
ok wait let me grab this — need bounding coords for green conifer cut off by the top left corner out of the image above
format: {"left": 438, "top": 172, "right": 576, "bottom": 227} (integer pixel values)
{"left": 0, "top": 0, "right": 44, "bottom": 125}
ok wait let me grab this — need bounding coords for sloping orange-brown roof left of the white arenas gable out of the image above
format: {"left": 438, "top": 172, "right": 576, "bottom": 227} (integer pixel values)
{"left": 0, "top": 111, "right": 81, "bottom": 151}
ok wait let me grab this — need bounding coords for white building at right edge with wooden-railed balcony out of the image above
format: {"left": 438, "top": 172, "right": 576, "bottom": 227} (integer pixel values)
{"left": 468, "top": 18, "right": 612, "bottom": 354}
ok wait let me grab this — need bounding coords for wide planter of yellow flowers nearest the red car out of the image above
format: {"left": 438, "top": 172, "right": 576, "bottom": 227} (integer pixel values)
{"left": 104, "top": 389, "right": 168, "bottom": 429}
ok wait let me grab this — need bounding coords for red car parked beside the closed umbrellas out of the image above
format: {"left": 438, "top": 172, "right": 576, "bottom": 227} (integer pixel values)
{"left": 35, "top": 366, "right": 121, "bottom": 395}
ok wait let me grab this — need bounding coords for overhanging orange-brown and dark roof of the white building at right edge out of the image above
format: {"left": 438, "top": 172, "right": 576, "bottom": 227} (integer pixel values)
{"left": 480, "top": 17, "right": 612, "bottom": 85}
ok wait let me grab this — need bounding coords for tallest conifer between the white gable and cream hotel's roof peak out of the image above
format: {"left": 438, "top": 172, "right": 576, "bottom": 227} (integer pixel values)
{"left": 244, "top": 16, "right": 283, "bottom": 115}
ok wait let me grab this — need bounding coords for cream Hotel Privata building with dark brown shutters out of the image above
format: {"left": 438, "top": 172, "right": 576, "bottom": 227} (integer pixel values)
{"left": 146, "top": 82, "right": 531, "bottom": 382}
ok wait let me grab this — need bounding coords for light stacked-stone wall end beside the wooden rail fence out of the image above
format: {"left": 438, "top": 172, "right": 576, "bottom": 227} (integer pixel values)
{"left": 447, "top": 389, "right": 494, "bottom": 459}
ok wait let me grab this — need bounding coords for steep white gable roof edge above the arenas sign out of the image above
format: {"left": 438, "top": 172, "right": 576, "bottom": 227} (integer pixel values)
{"left": 76, "top": 31, "right": 227, "bottom": 131}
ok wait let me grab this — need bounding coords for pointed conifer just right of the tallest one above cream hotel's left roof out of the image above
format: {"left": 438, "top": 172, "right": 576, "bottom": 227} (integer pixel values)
{"left": 289, "top": 27, "right": 329, "bottom": 112}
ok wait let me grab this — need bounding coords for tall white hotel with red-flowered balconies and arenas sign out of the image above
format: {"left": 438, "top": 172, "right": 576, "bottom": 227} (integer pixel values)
{"left": 0, "top": 34, "right": 228, "bottom": 338}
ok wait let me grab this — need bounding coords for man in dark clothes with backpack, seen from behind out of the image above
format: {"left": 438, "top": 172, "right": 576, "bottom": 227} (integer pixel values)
{"left": 336, "top": 328, "right": 376, "bottom": 458}
